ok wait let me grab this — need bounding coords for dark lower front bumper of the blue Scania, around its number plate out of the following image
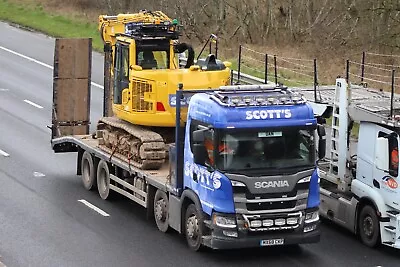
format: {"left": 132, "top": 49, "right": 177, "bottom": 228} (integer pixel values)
{"left": 203, "top": 222, "right": 321, "bottom": 249}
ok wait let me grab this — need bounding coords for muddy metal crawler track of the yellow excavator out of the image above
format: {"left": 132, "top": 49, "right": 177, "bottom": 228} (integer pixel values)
{"left": 97, "top": 117, "right": 167, "bottom": 170}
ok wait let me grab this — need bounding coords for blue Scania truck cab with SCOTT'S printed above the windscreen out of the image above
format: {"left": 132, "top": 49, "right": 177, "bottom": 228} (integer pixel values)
{"left": 170, "top": 86, "right": 320, "bottom": 248}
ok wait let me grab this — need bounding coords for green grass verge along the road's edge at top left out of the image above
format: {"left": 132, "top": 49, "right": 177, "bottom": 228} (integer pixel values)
{"left": 0, "top": 0, "right": 103, "bottom": 50}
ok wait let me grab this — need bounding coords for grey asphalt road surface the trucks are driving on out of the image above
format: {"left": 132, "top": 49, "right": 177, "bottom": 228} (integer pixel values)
{"left": 0, "top": 23, "right": 400, "bottom": 267}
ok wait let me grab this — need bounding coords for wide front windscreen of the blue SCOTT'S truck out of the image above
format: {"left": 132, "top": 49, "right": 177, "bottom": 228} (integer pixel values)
{"left": 216, "top": 128, "right": 315, "bottom": 174}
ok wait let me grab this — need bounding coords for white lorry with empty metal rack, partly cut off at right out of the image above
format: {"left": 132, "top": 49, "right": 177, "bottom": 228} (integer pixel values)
{"left": 302, "top": 78, "right": 400, "bottom": 249}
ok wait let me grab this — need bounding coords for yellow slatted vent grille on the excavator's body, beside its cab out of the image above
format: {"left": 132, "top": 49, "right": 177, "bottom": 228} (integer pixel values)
{"left": 132, "top": 79, "right": 153, "bottom": 112}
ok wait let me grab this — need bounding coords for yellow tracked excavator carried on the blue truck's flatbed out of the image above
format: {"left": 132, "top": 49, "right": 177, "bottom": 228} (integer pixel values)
{"left": 98, "top": 10, "right": 231, "bottom": 169}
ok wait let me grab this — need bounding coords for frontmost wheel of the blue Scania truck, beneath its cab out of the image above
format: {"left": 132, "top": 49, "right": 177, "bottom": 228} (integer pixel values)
{"left": 185, "top": 204, "right": 203, "bottom": 251}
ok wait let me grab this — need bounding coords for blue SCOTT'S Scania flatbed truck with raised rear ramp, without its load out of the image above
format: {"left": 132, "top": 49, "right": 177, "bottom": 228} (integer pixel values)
{"left": 51, "top": 37, "right": 325, "bottom": 251}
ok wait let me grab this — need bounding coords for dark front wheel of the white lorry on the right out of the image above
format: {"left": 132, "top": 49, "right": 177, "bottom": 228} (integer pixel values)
{"left": 358, "top": 205, "right": 380, "bottom": 247}
